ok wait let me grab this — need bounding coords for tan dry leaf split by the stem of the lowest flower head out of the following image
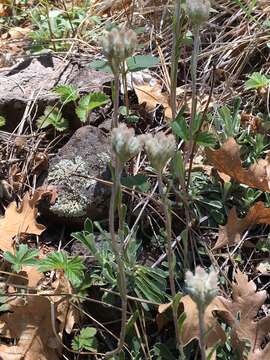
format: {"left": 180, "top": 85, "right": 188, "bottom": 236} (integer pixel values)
{"left": 181, "top": 295, "right": 228, "bottom": 348}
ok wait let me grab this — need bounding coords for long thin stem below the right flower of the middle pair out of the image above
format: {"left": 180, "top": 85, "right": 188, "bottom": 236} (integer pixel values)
{"left": 158, "top": 171, "right": 185, "bottom": 360}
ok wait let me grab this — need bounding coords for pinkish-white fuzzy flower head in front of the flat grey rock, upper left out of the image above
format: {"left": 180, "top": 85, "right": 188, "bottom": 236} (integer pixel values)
{"left": 101, "top": 28, "right": 137, "bottom": 72}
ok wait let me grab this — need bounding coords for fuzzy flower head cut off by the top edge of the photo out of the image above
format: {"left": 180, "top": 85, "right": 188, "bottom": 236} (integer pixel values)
{"left": 187, "top": 0, "right": 211, "bottom": 25}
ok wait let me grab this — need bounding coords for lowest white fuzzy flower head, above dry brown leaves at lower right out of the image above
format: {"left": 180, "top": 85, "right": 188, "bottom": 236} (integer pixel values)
{"left": 185, "top": 266, "right": 218, "bottom": 307}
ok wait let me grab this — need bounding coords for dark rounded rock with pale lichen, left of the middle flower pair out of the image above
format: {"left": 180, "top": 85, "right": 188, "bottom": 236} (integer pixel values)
{"left": 46, "top": 126, "right": 110, "bottom": 224}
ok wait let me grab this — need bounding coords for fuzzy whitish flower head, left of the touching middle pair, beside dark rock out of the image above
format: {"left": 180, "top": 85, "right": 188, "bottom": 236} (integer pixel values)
{"left": 112, "top": 124, "right": 142, "bottom": 164}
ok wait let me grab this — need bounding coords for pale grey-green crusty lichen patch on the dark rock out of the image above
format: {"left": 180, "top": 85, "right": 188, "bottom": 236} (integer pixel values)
{"left": 48, "top": 156, "right": 105, "bottom": 218}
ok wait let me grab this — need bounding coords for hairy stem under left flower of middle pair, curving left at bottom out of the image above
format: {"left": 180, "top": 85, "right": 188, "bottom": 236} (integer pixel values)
{"left": 105, "top": 158, "right": 127, "bottom": 358}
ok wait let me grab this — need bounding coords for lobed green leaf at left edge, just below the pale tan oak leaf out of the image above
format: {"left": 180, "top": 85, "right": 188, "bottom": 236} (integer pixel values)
{"left": 4, "top": 244, "right": 39, "bottom": 272}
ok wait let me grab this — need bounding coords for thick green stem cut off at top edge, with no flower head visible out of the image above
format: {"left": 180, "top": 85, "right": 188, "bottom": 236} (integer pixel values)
{"left": 170, "top": 0, "right": 182, "bottom": 119}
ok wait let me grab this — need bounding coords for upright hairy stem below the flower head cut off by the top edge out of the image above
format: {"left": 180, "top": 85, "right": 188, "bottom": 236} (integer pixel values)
{"left": 188, "top": 25, "right": 200, "bottom": 167}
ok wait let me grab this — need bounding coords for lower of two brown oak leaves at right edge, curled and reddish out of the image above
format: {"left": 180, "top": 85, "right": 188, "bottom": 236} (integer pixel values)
{"left": 213, "top": 201, "right": 270, "bottom": 250}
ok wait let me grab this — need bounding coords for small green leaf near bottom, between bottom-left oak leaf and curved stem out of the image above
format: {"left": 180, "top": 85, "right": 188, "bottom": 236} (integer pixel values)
{"left": 72, "top": 327, "right": 97, "bottom": 352}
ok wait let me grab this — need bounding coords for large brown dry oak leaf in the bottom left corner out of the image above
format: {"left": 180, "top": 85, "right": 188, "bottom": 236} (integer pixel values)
{"left": 0, "top": 296, "right": 61, "bottom": 360}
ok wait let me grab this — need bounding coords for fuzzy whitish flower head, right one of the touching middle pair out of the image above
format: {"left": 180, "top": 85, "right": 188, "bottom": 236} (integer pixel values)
{"left": 144, "top": 132, "right": 176, "bottom": 172}
